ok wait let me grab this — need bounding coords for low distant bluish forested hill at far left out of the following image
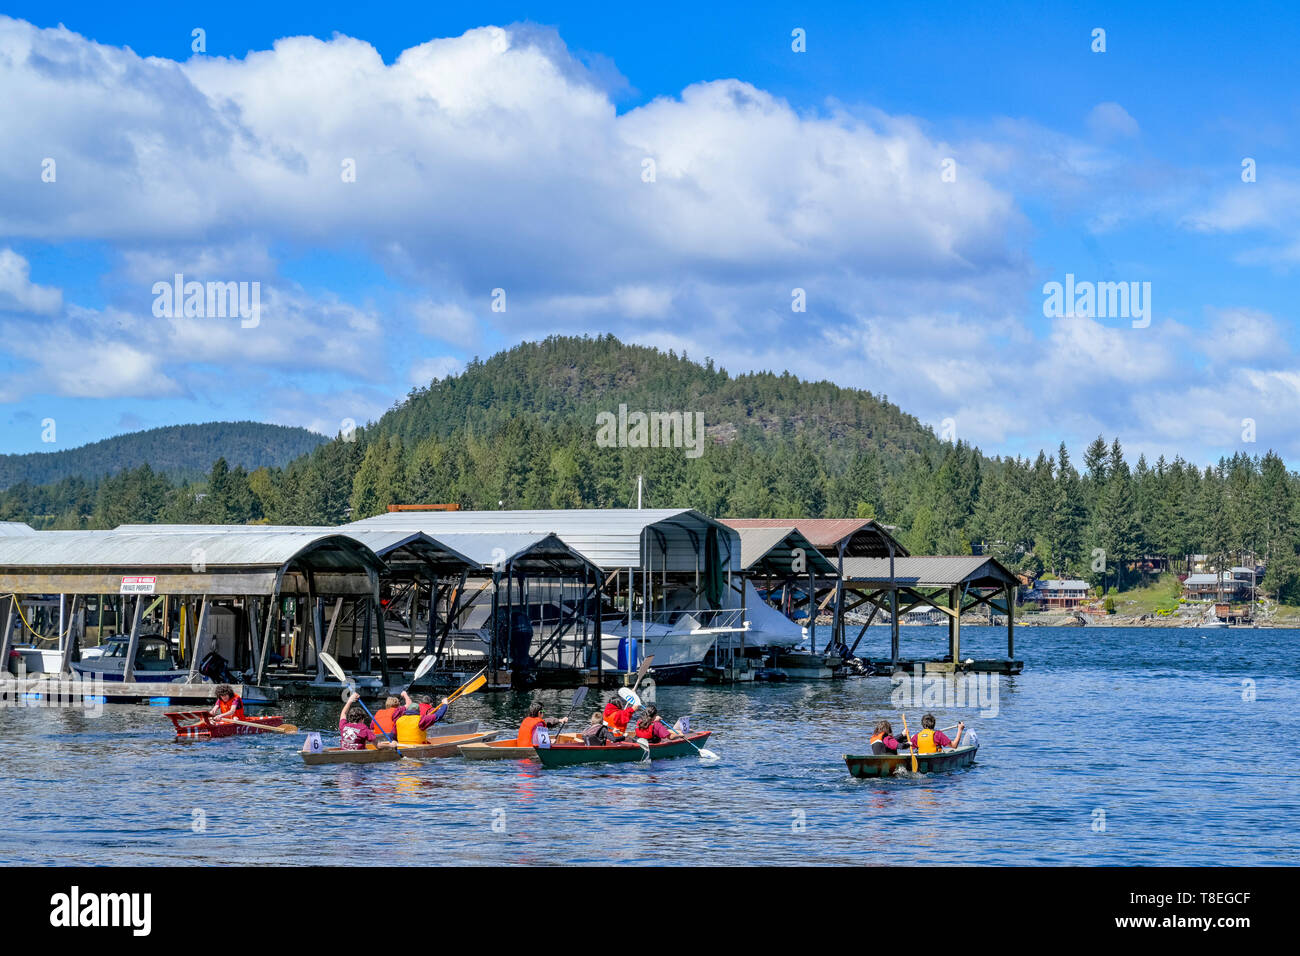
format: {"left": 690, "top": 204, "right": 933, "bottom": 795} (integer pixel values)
{"left": 0, "top": 421, "right": 325, "bottom": 489}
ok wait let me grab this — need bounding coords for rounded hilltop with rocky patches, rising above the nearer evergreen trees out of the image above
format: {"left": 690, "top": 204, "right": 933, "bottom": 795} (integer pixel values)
{"left": 367, "top": 336, "right": 939, "bottom": 455}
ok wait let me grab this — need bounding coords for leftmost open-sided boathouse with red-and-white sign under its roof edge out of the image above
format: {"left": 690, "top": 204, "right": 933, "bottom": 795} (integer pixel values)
{"left": 0, "top": 525, "right": 385, "bottom": 702}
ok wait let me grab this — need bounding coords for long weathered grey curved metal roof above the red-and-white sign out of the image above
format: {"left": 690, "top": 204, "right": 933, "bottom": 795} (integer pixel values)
{"left": 0, "top": 525, "right": 382, "bottom": 568}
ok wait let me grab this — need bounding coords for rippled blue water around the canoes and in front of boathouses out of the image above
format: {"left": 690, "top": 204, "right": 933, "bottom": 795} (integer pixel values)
{"left": 0, "top": 627, "right": 1300, "bottom": 865}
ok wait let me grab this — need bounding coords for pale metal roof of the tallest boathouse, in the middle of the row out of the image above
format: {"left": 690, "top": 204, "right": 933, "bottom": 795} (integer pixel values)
{"left": 341, "top": 509, "right": 740, "bottom": 571}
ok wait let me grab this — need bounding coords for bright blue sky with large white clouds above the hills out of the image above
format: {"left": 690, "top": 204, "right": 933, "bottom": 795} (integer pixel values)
{"left": 0, "top": 3, "right": 1300, "bottom": 462}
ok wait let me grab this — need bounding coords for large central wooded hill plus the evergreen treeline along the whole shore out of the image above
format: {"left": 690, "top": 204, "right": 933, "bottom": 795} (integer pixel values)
{"left": 0, "top": 337, "right": 1300, "bottom": 604}
